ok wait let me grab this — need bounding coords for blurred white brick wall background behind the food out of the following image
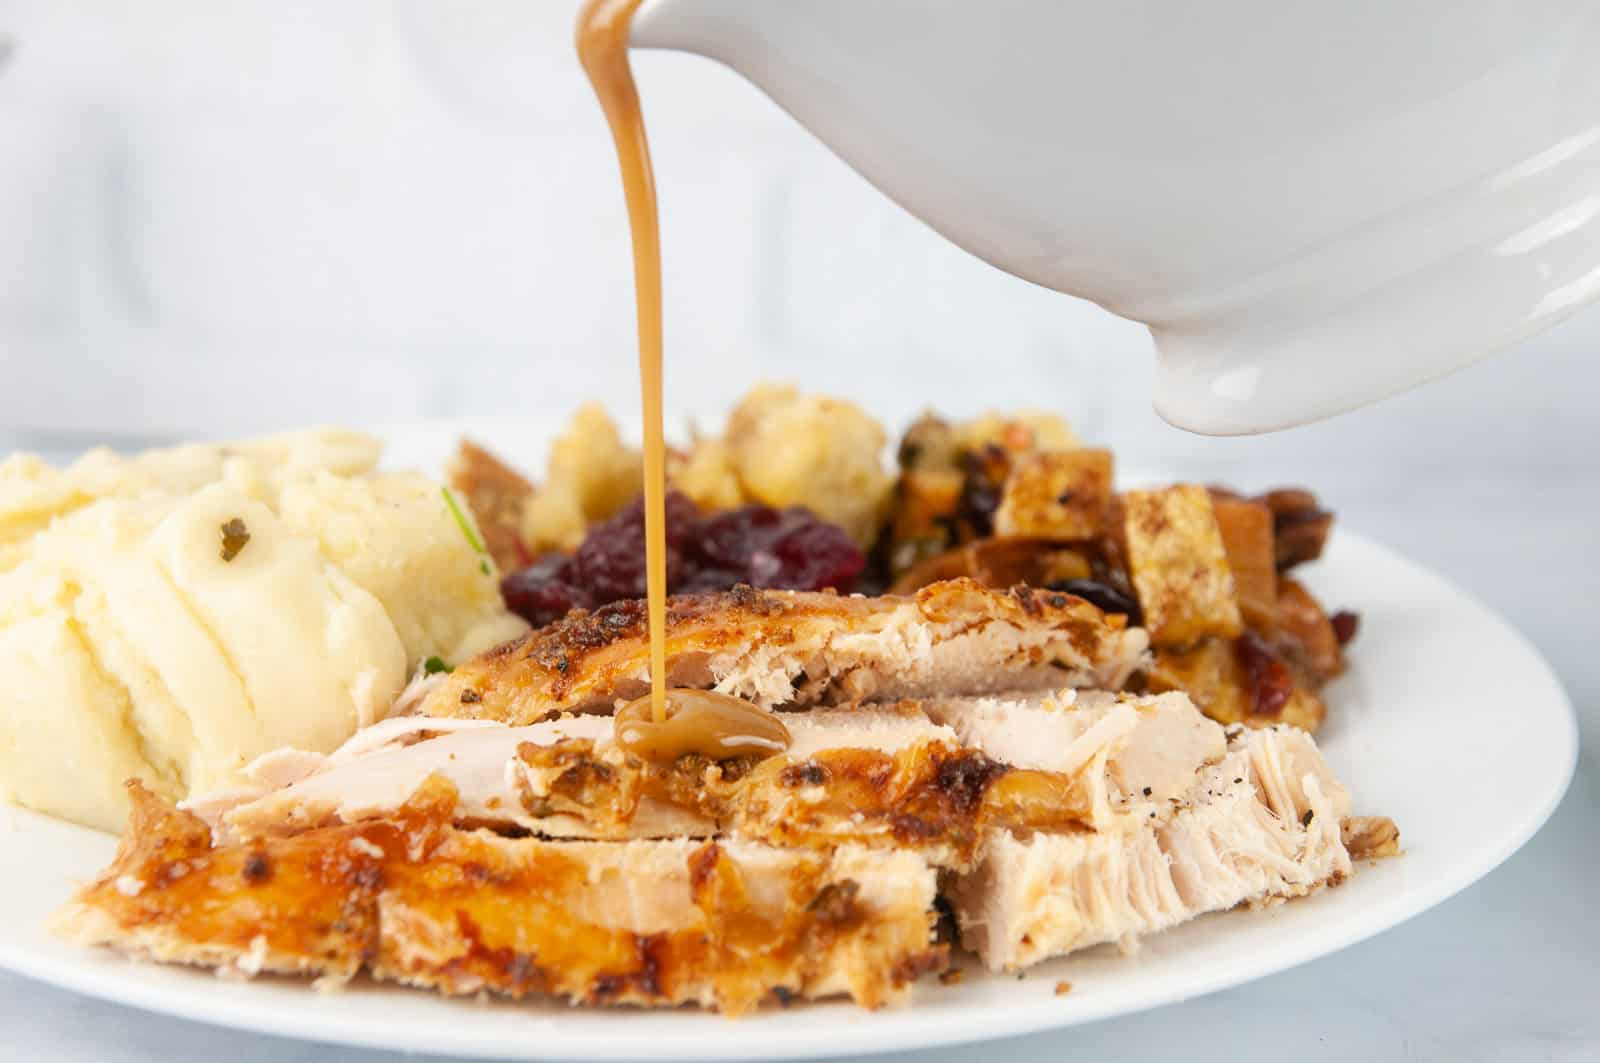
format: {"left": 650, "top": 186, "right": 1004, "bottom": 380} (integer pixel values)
{"left": 0, "top": 0, "right": 1600, "bottom": 475}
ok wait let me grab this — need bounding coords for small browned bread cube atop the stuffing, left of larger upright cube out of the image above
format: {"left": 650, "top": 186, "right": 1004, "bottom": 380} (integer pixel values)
{"left": 995, "top": 450, "right": 1112, "bottom": 540}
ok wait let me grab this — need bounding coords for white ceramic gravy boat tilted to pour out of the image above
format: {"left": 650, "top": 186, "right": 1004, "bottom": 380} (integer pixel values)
{"left": 632, "top": 0, "right": 1600, "bottom": 434}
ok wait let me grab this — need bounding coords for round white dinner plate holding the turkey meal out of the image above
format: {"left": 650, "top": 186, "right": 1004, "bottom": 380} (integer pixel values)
{"left": 0, "top": 421, "right": 1578, "bottom": 1060}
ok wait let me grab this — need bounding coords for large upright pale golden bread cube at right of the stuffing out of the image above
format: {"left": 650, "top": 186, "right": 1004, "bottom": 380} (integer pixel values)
{"left": 1122, "top": 483, "right": 1242, "bottom": 647}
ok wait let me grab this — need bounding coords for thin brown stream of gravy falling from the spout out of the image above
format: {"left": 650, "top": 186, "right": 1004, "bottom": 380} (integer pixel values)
{"left": 578, "top": 0, "right": 667, "bottom": 724}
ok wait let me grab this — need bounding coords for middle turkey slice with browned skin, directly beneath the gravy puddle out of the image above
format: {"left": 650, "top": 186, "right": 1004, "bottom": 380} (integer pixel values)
{"left": 194, "top": 701, "right": 1104, "bottom": 868}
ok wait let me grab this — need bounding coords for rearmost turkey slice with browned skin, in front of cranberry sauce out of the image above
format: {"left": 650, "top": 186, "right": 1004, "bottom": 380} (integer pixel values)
{"left": 421, "top": 580, "right": 1147, "bottom": 724}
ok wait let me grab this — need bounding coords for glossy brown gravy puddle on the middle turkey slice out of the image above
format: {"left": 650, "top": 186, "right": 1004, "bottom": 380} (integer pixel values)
{"left": 616, "top": 690, "right": 792, "bottom": 762}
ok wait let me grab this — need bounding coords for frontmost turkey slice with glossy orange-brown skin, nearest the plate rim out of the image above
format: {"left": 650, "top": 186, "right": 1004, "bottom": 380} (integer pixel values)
{"left": 56, "top": 778, "right": 946, "bottom": 1013}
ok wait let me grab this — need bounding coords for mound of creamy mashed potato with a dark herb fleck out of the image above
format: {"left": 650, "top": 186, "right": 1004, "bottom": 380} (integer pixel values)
{"left": 0, "top": 432, "right": 523, "bottom": 829}
